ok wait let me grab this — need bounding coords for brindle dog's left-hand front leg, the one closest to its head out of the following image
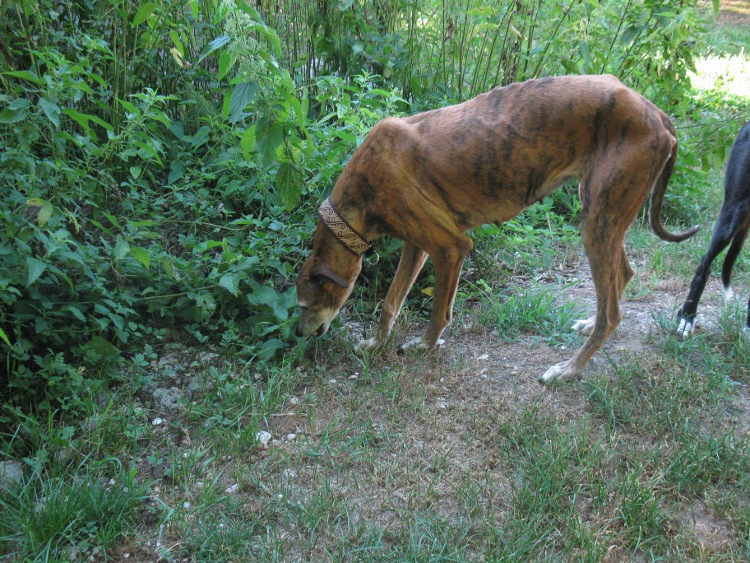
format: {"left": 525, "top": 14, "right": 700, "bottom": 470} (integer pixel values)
{"left": 359, "top": 241, "right": 427, "bottom": 349}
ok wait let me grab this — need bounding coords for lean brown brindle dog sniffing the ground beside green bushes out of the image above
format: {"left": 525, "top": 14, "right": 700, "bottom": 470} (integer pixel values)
{"left": 297, "top": 76, "right": 699, "bottom": 382}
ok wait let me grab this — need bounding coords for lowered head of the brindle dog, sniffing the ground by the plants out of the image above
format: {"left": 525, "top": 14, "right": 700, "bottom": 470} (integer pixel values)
{"left": 297, "top": 255, "right": 359, "bottom": 336}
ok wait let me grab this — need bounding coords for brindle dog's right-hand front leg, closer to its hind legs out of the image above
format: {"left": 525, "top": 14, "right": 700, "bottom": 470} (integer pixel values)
{"left": 400, "top": 235, "right": 474, "bottom": 352}
